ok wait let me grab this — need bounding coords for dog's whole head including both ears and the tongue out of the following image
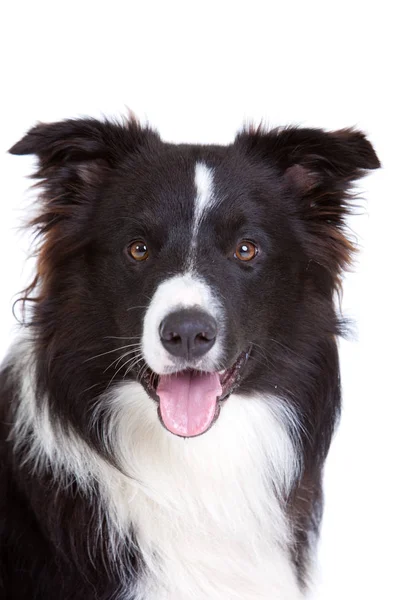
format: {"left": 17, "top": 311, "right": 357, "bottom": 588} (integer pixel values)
{"left": 12, "top": 120, "right": 378, "bottom": 437}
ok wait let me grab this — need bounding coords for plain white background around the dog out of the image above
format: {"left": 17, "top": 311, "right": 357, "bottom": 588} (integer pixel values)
{"left": 0, "top": 0, "right": 400, "bottom": 600}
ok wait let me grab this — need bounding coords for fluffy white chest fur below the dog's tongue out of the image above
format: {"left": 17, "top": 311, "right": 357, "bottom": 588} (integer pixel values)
{"left": 97, "top": 384, "right": 302, "bottom": 600}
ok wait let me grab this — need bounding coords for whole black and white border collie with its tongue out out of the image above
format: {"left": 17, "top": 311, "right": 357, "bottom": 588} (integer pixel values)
{"left": 0, "top": 119, "right": 379, "bottom": 600}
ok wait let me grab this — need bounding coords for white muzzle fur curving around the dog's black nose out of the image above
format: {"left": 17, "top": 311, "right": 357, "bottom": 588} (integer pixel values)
{"left": 142, "top": 273, "right": 223, "bottom": 374}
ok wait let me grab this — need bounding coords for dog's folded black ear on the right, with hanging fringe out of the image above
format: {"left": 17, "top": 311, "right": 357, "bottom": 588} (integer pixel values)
{"left": 235, "top": 127, "right": 380, "bottom": 283}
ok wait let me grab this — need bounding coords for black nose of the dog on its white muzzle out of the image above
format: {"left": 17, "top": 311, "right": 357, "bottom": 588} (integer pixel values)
{"left": 160, "top": 309, "right": 217, "bottom": 360}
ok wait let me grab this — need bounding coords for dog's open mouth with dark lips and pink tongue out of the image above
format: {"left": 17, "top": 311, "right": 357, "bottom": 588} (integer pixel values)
{"left": 141, "top": 349, "right": 250, "bottom": 437}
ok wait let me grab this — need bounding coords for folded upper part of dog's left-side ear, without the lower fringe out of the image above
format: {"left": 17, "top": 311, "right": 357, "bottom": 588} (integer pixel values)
{"left": 9, "top": 118, "right": 159, "bottom": 233}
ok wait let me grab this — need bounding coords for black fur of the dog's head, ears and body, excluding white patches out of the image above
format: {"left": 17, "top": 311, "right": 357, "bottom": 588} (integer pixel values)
{"left": 0, "top": 119, "right": 379, "bottom": 600}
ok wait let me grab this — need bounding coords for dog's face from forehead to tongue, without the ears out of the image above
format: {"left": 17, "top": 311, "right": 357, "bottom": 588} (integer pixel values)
{"left": 89, "top": 146, "right": 307, "bottom": 436}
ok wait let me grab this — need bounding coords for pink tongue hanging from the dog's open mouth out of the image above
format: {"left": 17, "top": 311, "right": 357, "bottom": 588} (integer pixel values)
{"left": 157, "top": 371, "right": 222, "bottom": 437}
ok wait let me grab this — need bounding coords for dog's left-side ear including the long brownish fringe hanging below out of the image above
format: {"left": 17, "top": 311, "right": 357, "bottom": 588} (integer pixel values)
{"left": 10, "top": 118, "right": 159, "bottom": 310}
